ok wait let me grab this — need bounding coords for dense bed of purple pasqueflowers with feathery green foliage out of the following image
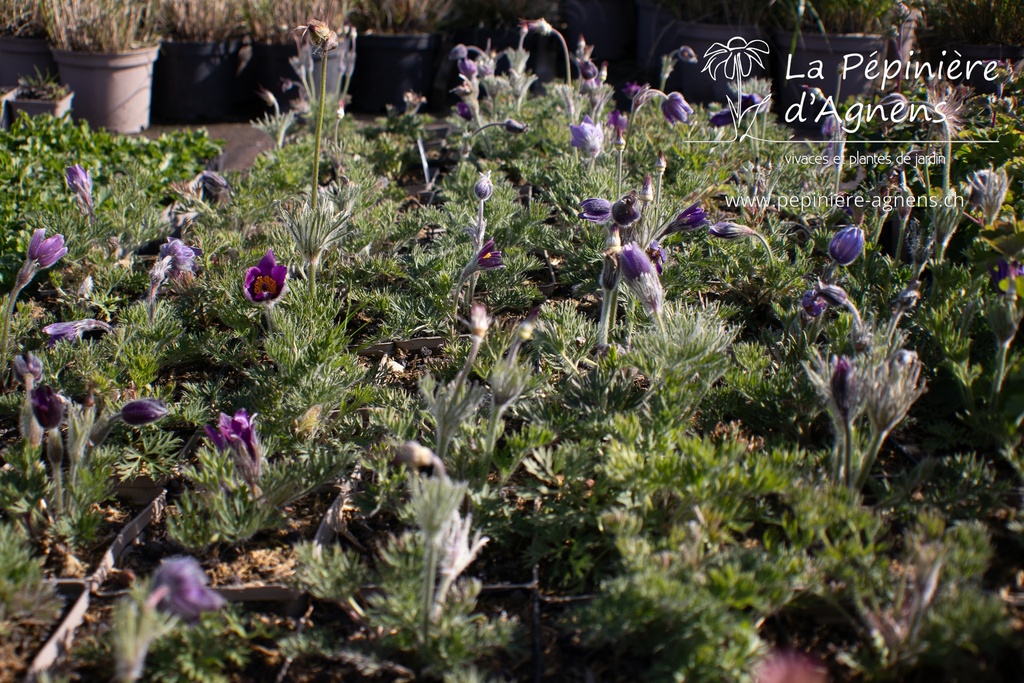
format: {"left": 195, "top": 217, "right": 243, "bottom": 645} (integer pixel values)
{"left": 0, "top": 22, "right": 1024, "bottom": 682}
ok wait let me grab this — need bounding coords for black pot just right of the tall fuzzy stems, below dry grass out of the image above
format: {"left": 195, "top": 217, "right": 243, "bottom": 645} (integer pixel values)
{"left": 349, "top": 34, "right": 440, "bottom": 114}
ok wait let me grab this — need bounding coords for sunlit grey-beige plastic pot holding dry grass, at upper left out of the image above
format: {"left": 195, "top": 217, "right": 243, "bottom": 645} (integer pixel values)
{"left": 53, "top": 47, "right": 160, "bottom": 133}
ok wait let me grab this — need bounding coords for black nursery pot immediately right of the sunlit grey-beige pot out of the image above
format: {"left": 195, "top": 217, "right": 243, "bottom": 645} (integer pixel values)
{"left": 153, "top": 40, "right": 242, "bottom": 123}
